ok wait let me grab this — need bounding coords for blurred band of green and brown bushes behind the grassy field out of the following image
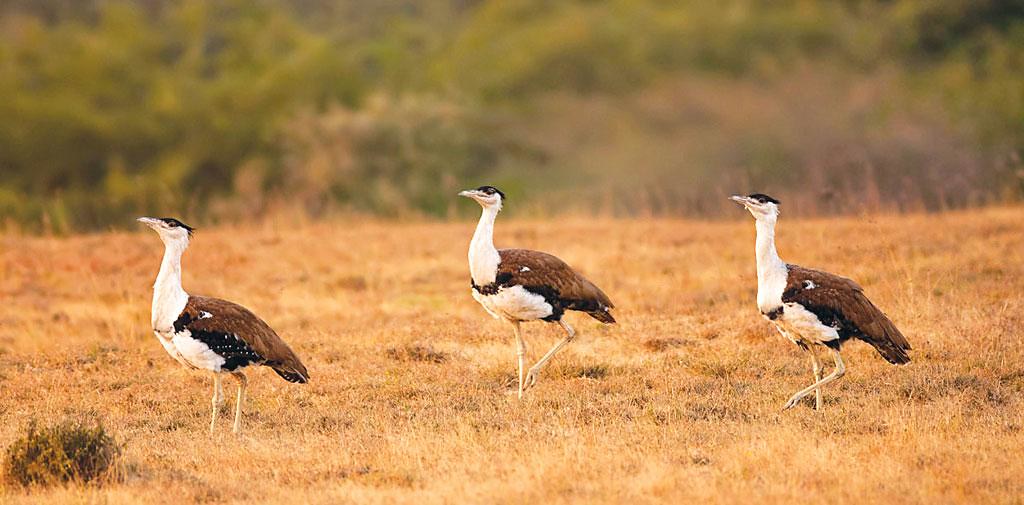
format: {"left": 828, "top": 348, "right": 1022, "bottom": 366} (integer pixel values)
{"left": 0, "top": 0, "right": 1024, "bottom": 232}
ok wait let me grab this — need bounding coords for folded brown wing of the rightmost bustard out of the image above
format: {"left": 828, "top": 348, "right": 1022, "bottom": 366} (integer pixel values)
{"left": 782, "top": 265, "right": 910, "bottom": 365}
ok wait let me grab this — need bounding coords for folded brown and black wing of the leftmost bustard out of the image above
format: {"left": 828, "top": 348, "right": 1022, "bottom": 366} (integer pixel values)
{"left": 174, "top": 296, "right": 309, "bottom": 383}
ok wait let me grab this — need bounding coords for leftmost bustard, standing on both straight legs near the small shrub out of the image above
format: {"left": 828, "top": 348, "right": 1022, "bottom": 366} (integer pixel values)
{"left": 138, "top": 217, "right": 309, "bottom": 433}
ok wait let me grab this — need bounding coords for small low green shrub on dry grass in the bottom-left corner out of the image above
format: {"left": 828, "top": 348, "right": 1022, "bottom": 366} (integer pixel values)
{"left": 4, "top": 420, "right": 120, "bottom": 486}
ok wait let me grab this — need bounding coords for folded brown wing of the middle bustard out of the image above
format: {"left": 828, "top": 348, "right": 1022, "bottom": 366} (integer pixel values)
{"left": 497, "top": 249, "right": 615, "bottom": 324}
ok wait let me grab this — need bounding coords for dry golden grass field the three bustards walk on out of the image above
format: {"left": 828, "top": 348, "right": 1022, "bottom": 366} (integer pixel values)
{"left": 0, "top": 208, "right": 1024, "bottom": 504}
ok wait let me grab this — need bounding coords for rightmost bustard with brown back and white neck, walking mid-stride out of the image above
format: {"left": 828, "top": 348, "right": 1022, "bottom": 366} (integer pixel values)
{"left": 731, "top": 194, "right": 910, "bottom": 410}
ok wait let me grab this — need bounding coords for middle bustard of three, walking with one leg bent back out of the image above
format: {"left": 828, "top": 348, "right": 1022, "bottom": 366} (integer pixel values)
{"left": 459, "top": 185, "right": 615, "bottom": 398}
